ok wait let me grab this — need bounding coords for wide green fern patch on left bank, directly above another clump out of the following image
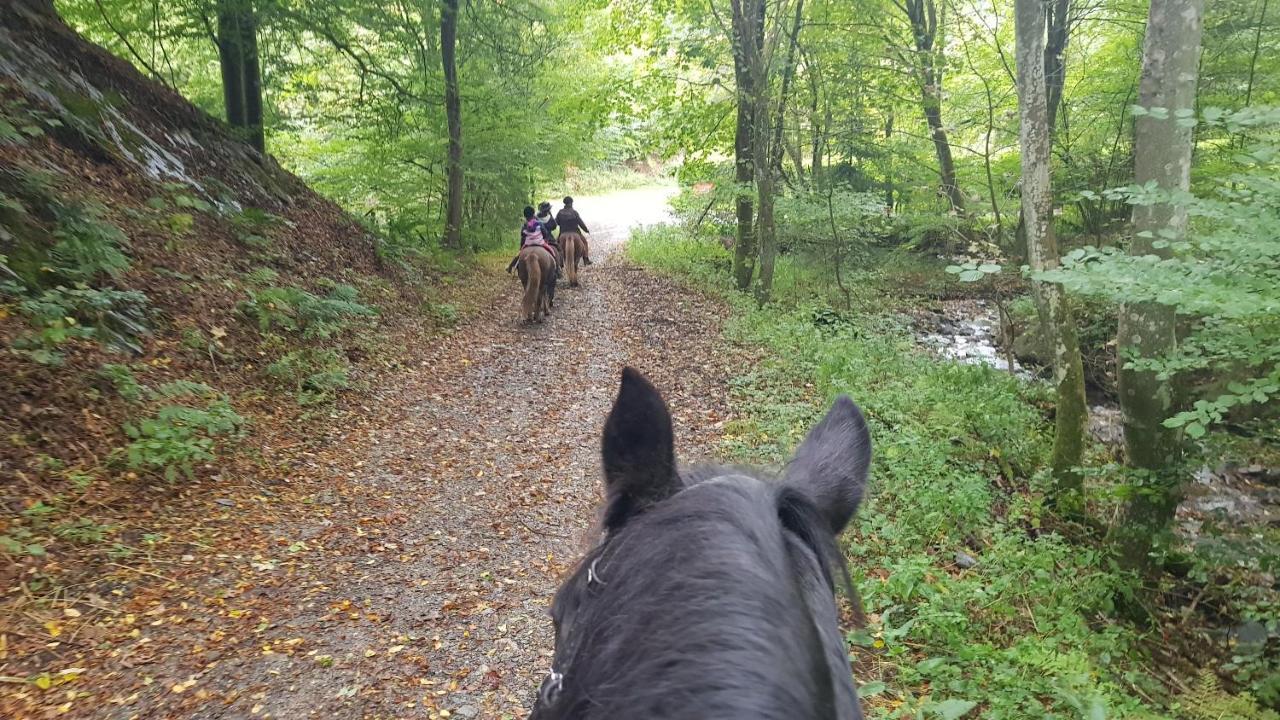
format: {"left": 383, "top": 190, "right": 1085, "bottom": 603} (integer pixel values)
{"left": 239, "top": 279, "right": 375, "bottom": 340}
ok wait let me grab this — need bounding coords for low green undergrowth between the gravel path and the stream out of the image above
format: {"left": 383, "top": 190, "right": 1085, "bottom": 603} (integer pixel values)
{"left": 628, "top": 221, "right": 1172, "bottom": 719}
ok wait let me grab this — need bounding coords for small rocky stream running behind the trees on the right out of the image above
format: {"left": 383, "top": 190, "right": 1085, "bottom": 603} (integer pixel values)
{"left": 913, "top": 300, "right": 1280, "bottom": 542}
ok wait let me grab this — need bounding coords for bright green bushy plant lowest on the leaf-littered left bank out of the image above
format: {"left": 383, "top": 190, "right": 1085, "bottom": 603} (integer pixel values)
{"left": 123, "top": 380, "right": 244, "bottom": 482}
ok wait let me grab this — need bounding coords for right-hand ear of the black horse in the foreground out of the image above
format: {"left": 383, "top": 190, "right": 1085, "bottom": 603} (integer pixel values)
{"left": 786, "top": 395, "right": 872, "bottom": 533}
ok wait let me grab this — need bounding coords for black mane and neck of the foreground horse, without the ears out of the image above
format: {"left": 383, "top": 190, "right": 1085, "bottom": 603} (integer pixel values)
{"left": 532, "top": 466, "right": 860, "bottom": 720}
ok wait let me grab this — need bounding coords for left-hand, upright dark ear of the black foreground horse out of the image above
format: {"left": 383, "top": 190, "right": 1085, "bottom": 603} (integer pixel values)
{"left": 602, "top": 368, "right": 682, "bottom": 530}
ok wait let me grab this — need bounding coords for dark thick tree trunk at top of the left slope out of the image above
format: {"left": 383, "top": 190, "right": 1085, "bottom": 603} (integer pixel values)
{"left": 218, "top": 0, "right": 266, "bottom": 152}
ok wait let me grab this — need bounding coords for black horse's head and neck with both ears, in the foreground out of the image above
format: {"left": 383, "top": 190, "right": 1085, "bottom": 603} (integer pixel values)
{"left": 532, "top": 368, "right": 870, "bottom": 720}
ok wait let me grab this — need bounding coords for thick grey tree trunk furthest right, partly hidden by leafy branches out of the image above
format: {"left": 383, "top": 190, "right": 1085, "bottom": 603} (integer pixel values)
{"left": 1116, "top": 0, "right": 1204, "bottom": 571}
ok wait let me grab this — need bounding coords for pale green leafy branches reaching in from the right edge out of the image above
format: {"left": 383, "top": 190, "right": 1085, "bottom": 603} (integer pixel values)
{"left": 1042, "top": 108, "right": 1280, "bottom": 437}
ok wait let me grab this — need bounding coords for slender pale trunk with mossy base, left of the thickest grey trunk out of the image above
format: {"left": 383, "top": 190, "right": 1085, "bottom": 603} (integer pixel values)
{"left": 1014, "top": 0, "right": 1088, "bottom": 512}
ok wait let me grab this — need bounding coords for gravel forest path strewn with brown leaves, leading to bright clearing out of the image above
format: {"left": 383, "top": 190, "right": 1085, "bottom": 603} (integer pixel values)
{"left": 77, "top": 190, "right": 733, "bottom": 719}
